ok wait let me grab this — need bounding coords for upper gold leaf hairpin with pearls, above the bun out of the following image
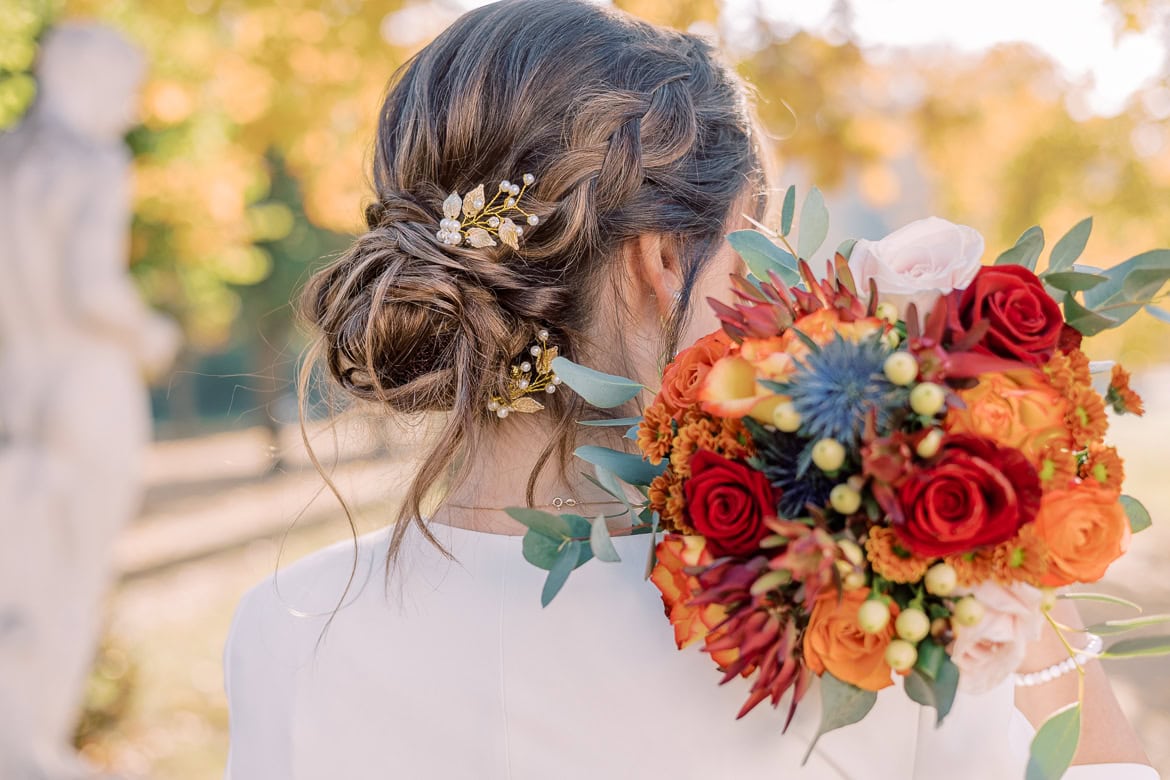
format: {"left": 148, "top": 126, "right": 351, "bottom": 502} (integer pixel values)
{"left": 435, "top": 173, "right": 541, "bottom": 249}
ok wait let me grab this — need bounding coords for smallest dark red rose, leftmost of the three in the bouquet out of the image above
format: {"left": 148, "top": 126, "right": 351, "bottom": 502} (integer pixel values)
{"left": 683, "top": 449, "right": 779, "bottom": 557}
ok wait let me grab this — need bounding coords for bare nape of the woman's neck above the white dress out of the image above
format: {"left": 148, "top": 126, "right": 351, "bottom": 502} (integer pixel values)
{"left": 433, "top": 413, "right": 625, "bottom": 534}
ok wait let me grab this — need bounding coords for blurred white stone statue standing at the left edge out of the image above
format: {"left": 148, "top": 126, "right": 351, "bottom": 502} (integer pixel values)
{"left": 0, "top": 25, "right": 179, "bottom": 780}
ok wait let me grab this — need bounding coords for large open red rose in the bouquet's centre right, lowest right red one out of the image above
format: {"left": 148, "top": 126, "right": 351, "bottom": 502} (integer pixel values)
{"left": 894, "top": 435, "right": 1041, "bottom": 557}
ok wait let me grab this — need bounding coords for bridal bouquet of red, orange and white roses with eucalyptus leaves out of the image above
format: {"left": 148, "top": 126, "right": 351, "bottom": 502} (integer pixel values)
{"left": 510, "top": 189, "right": 1170, "bottom": 778}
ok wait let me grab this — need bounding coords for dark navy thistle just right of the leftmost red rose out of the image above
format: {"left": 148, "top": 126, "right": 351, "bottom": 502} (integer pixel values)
{"left": 743, "top": 417, "right": 837, "bottom": 519}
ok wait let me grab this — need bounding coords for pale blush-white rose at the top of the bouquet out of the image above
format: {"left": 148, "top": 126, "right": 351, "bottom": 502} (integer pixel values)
{"left": 849, "top": 216, "right": 984, "bottom": 320}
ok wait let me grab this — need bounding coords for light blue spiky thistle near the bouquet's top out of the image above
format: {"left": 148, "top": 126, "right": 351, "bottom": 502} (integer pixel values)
{"left": 770, "top": 334, "right": 907, "bottom": 449}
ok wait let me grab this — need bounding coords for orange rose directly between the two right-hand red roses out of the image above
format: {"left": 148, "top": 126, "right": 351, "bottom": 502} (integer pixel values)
{"left": 947, "top": 370, "right": 1072, "bottom": 469}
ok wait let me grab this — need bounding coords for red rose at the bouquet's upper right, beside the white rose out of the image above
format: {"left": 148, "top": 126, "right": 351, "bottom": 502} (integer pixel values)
{"left": 950, "top": 265, "right": 1065, "bottom": 366}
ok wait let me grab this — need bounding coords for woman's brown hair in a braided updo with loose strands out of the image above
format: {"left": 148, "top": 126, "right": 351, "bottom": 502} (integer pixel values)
{"left": 302, "top": 0, "right": 764, "bottom": 558}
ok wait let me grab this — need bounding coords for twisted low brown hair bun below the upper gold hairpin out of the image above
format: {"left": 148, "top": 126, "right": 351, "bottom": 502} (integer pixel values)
{"left": 303, "top": 206, "right": 522, "bottom": 413}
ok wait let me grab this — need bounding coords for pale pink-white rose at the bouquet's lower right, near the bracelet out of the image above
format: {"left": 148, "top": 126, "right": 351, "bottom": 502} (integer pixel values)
{"left": 950, "top": 582, "right": 1044, "bottom": 693}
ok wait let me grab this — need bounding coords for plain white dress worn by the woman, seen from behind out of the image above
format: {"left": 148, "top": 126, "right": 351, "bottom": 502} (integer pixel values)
{"left": 223, "top": 525, "right": 1157, "bottom": 780}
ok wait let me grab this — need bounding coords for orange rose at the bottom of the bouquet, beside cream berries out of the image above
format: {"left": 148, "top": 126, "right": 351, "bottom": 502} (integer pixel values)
{"left": 804, "top": 588, "right": 896, "bottom": 691}
